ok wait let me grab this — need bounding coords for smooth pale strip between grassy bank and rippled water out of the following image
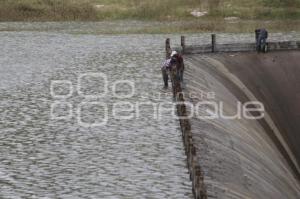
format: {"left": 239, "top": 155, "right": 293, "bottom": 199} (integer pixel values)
{"left": 0, "top": 20, "right": 300, "bottom": 34}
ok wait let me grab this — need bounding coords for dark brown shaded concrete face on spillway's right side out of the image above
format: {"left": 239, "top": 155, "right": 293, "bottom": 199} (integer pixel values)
{"left": 217, "top": 51, "right": 300, "bottom": 176}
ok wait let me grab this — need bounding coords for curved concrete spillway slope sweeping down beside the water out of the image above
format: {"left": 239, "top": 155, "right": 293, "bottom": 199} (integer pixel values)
{"left": 184, "top": 51, "right": 300, "bottom": 199}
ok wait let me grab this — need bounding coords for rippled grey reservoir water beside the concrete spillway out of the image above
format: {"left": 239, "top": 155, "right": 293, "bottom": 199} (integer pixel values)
{"left": 0, "top": 23, "right": 300, "bottom": 199}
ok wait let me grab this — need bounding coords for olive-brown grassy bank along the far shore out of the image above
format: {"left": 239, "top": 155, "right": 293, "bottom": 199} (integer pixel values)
{"left": 0, "top": 0, "right": 300, "bottom": 21}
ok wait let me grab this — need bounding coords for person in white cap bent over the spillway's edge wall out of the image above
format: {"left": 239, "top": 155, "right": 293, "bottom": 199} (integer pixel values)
{"left": 161, "top": 51, "right": 184, "bottom": 88}
